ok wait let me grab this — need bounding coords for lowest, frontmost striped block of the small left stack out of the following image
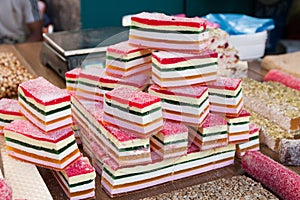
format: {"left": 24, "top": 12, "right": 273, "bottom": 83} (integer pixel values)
{"left": 52, "top": 157, "right": 96, "bottom": 199}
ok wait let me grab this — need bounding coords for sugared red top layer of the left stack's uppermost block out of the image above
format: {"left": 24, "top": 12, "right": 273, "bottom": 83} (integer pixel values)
{"left": 19, "top": 77, "right": 70, "bottom": 106}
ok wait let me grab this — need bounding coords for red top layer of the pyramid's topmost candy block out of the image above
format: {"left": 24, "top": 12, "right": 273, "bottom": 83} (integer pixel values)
{"left": 131, "top": 12, "right": 207, "bottom": 30}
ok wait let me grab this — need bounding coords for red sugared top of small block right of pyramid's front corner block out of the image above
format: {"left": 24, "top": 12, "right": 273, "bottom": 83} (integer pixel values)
{"left": 160, "top": 120, "right": 188, "bottom": 136}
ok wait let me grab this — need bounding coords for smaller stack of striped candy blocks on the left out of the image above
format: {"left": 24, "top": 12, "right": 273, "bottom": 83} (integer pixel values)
{"left": 0, "top": 77, "right": 96, "bottom": 199}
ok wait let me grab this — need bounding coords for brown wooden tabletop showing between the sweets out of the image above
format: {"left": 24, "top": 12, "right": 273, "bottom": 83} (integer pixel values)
{"left": 1, "top": 42, "right": 300, "bottom": 200}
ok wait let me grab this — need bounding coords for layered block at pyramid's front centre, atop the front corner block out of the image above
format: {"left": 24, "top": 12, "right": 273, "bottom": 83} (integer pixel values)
{"left": 103, "top": 87, "right": 163, "bottom": 138}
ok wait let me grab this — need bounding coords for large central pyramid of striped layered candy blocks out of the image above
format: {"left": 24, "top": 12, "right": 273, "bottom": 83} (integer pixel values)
{"left": 66, "top": 13, "right": 259, "bottom": 196}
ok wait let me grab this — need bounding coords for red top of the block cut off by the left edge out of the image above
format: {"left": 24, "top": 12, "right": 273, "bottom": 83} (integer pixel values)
{"left": 0, "top": 98, "right": 23, "bottom": 116}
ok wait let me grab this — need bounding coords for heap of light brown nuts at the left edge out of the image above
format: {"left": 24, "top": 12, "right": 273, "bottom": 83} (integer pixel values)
{"left": 0, "top": 52, "right": 34, "bottom": 98}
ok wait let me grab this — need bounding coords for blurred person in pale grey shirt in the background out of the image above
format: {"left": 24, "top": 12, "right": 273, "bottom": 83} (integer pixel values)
{"left": 0, "top": 0, "right": 43, "bottom": 44}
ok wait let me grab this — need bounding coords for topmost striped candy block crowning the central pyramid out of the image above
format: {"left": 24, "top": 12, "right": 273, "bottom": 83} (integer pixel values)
{"left": 129, "top": 12, "right": 209, "bottom": 52}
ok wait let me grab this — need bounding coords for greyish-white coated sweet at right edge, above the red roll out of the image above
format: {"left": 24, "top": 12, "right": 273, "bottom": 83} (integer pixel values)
{"left": 278, "top": 139, "right": 300, "bottom": 166}
